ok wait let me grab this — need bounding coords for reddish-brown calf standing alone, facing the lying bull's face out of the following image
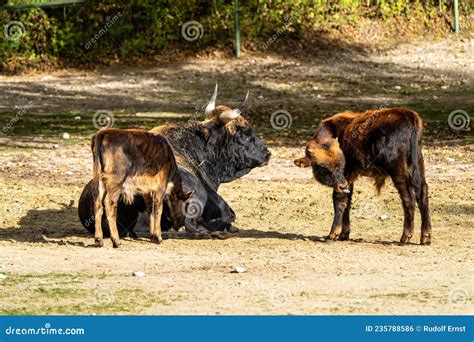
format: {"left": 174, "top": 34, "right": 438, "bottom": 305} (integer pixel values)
{"left": 295, "top": 109, "right": 431, "bottom": 245}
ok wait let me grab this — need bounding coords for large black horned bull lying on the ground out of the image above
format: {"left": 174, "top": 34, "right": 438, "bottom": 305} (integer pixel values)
{"left": 79, "top": 85, "right": 271, "bottom": 239}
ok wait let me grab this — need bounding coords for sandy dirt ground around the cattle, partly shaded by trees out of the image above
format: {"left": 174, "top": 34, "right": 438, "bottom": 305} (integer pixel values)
{"left": 0, "top": 40, "right": 474, "bottom": 315}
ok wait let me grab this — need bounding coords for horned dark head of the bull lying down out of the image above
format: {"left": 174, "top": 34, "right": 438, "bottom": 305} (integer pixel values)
{"left": 200, "top": 84, "right": 271, "bottom": 182}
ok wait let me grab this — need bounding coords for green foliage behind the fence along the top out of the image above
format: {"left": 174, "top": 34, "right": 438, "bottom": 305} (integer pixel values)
{"left": 0, "top": 0, "right": 472, "bottom": 66}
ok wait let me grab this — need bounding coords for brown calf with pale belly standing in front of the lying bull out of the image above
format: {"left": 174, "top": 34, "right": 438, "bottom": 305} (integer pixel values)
{"left": 91, "top": 128, "right": 189, "bottom": 248}
